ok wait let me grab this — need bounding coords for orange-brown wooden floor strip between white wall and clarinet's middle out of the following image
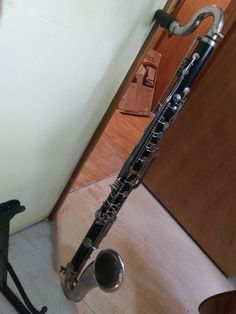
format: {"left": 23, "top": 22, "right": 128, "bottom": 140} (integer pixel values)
{"left": 71, "top": 110, "right": 151, "bottom": 191}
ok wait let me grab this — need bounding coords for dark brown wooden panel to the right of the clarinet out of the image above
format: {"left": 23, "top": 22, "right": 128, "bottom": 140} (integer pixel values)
{"left": 145, "top": 1, "right": 236, "bottom": 275}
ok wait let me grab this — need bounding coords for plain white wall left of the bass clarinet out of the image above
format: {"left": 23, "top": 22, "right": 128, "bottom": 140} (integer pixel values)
{"left": 0, "top": 0, "right": 166, "bottom": 231}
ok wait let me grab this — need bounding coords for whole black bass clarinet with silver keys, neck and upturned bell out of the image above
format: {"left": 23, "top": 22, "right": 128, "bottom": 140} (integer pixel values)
{"left": 62, "top": 5, "right": 224, "bottom": 302}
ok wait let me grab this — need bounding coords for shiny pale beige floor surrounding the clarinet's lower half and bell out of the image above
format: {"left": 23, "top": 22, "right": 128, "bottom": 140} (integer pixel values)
{"left": 54, "top": 177, "right": 232, "bottom": 314}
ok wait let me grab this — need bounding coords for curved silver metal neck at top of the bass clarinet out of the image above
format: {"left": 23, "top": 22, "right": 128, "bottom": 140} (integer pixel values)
{"left": 169, "top": 5, "right": 224, "bottom": 40}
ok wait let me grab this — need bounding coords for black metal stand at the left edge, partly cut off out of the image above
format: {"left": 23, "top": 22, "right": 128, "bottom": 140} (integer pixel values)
{"left": 0, "top": 200, "right": 47, "bottom": 314}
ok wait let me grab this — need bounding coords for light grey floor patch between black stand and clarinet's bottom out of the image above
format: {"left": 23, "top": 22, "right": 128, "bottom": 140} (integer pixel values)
{"left": 0, "top": 221, "right": 80, "bottom": 314}
